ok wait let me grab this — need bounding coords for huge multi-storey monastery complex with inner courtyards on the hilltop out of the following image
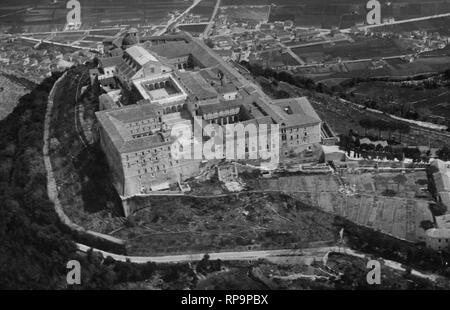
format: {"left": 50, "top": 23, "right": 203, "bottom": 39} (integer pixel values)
{"left": 95, "top": 34, "right": 322, "bottom": 197}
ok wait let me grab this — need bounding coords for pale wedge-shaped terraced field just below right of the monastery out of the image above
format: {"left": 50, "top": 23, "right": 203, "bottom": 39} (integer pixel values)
{"left": 241, "top": 171, "right": 433, "bottom": 242}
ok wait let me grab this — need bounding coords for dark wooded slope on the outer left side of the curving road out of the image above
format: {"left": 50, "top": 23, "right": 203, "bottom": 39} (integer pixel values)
{"left": 0, "top": 69, "right": 206, "bottom": 289}
